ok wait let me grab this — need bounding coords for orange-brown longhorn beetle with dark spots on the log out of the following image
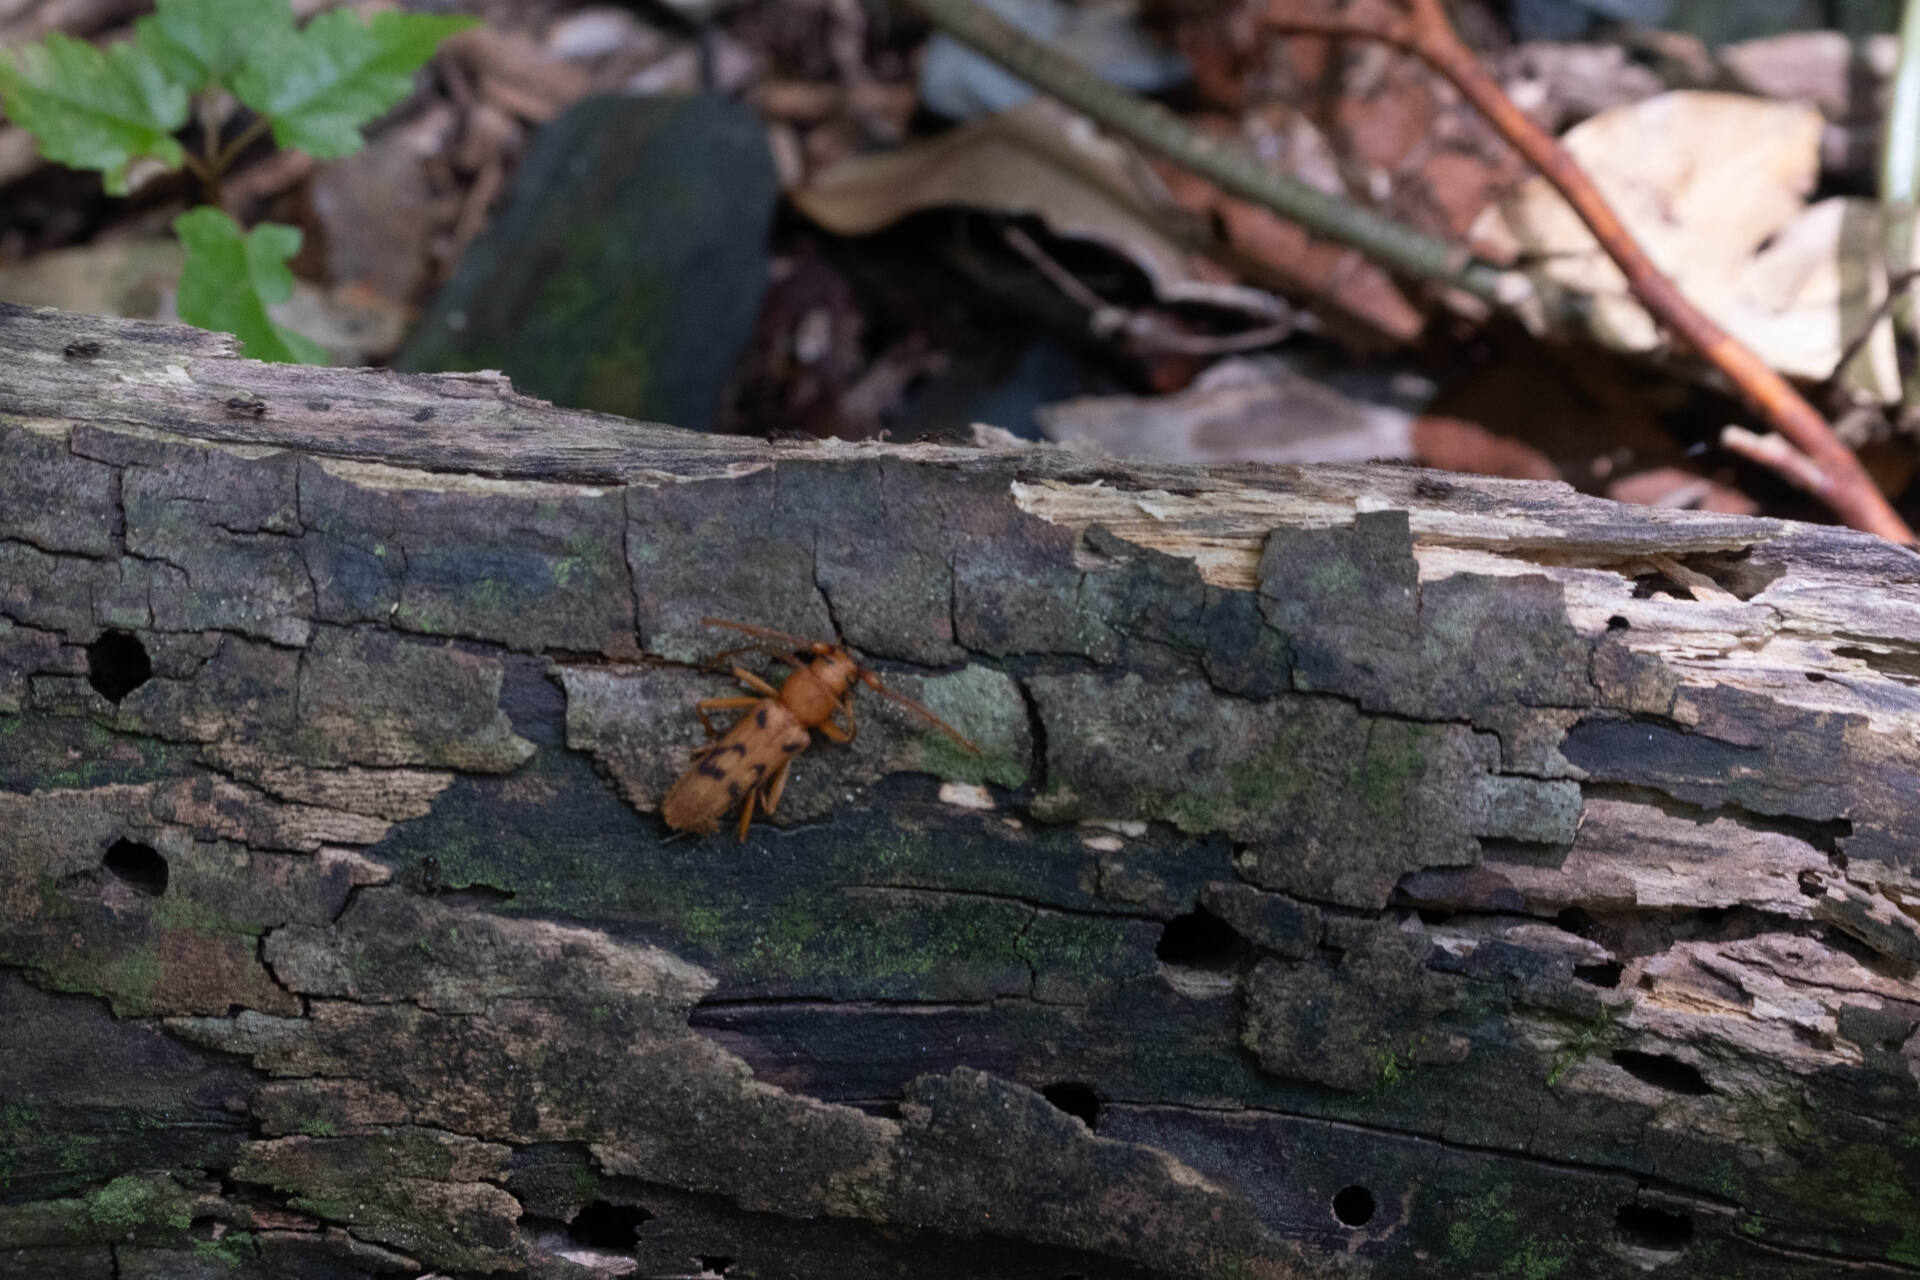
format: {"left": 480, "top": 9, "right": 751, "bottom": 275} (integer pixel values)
{"left": 660, "top": 618, "right": 979, "bottom": 841}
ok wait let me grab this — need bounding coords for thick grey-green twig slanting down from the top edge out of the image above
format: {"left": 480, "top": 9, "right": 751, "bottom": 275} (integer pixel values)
{"left": 895, "top": 0, "right": 1532, "bottom": 303}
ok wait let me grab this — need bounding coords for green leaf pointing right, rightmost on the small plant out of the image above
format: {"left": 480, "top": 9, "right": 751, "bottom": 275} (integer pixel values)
{"left": 232, "top": 10, "right": 478, "bottom": 159}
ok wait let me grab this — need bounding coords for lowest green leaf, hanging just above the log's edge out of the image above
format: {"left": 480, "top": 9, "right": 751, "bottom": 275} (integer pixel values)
{"left": 173, "top": 207, "right": 326, "bottom": 365}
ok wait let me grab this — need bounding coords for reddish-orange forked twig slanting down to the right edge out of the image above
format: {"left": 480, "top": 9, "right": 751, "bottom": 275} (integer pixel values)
{"left": 1267, "top": 0, "right": 1914, "bottom": 543}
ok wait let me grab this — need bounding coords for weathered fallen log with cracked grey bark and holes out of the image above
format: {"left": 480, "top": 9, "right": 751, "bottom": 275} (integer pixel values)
{"left": 0, "top": 309, "right": 1920, "bottom": 1280}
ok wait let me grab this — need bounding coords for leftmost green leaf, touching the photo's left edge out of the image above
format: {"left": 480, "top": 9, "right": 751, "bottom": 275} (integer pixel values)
{"left": 0, "top": 31, "right": 186, "bottom": 196}
